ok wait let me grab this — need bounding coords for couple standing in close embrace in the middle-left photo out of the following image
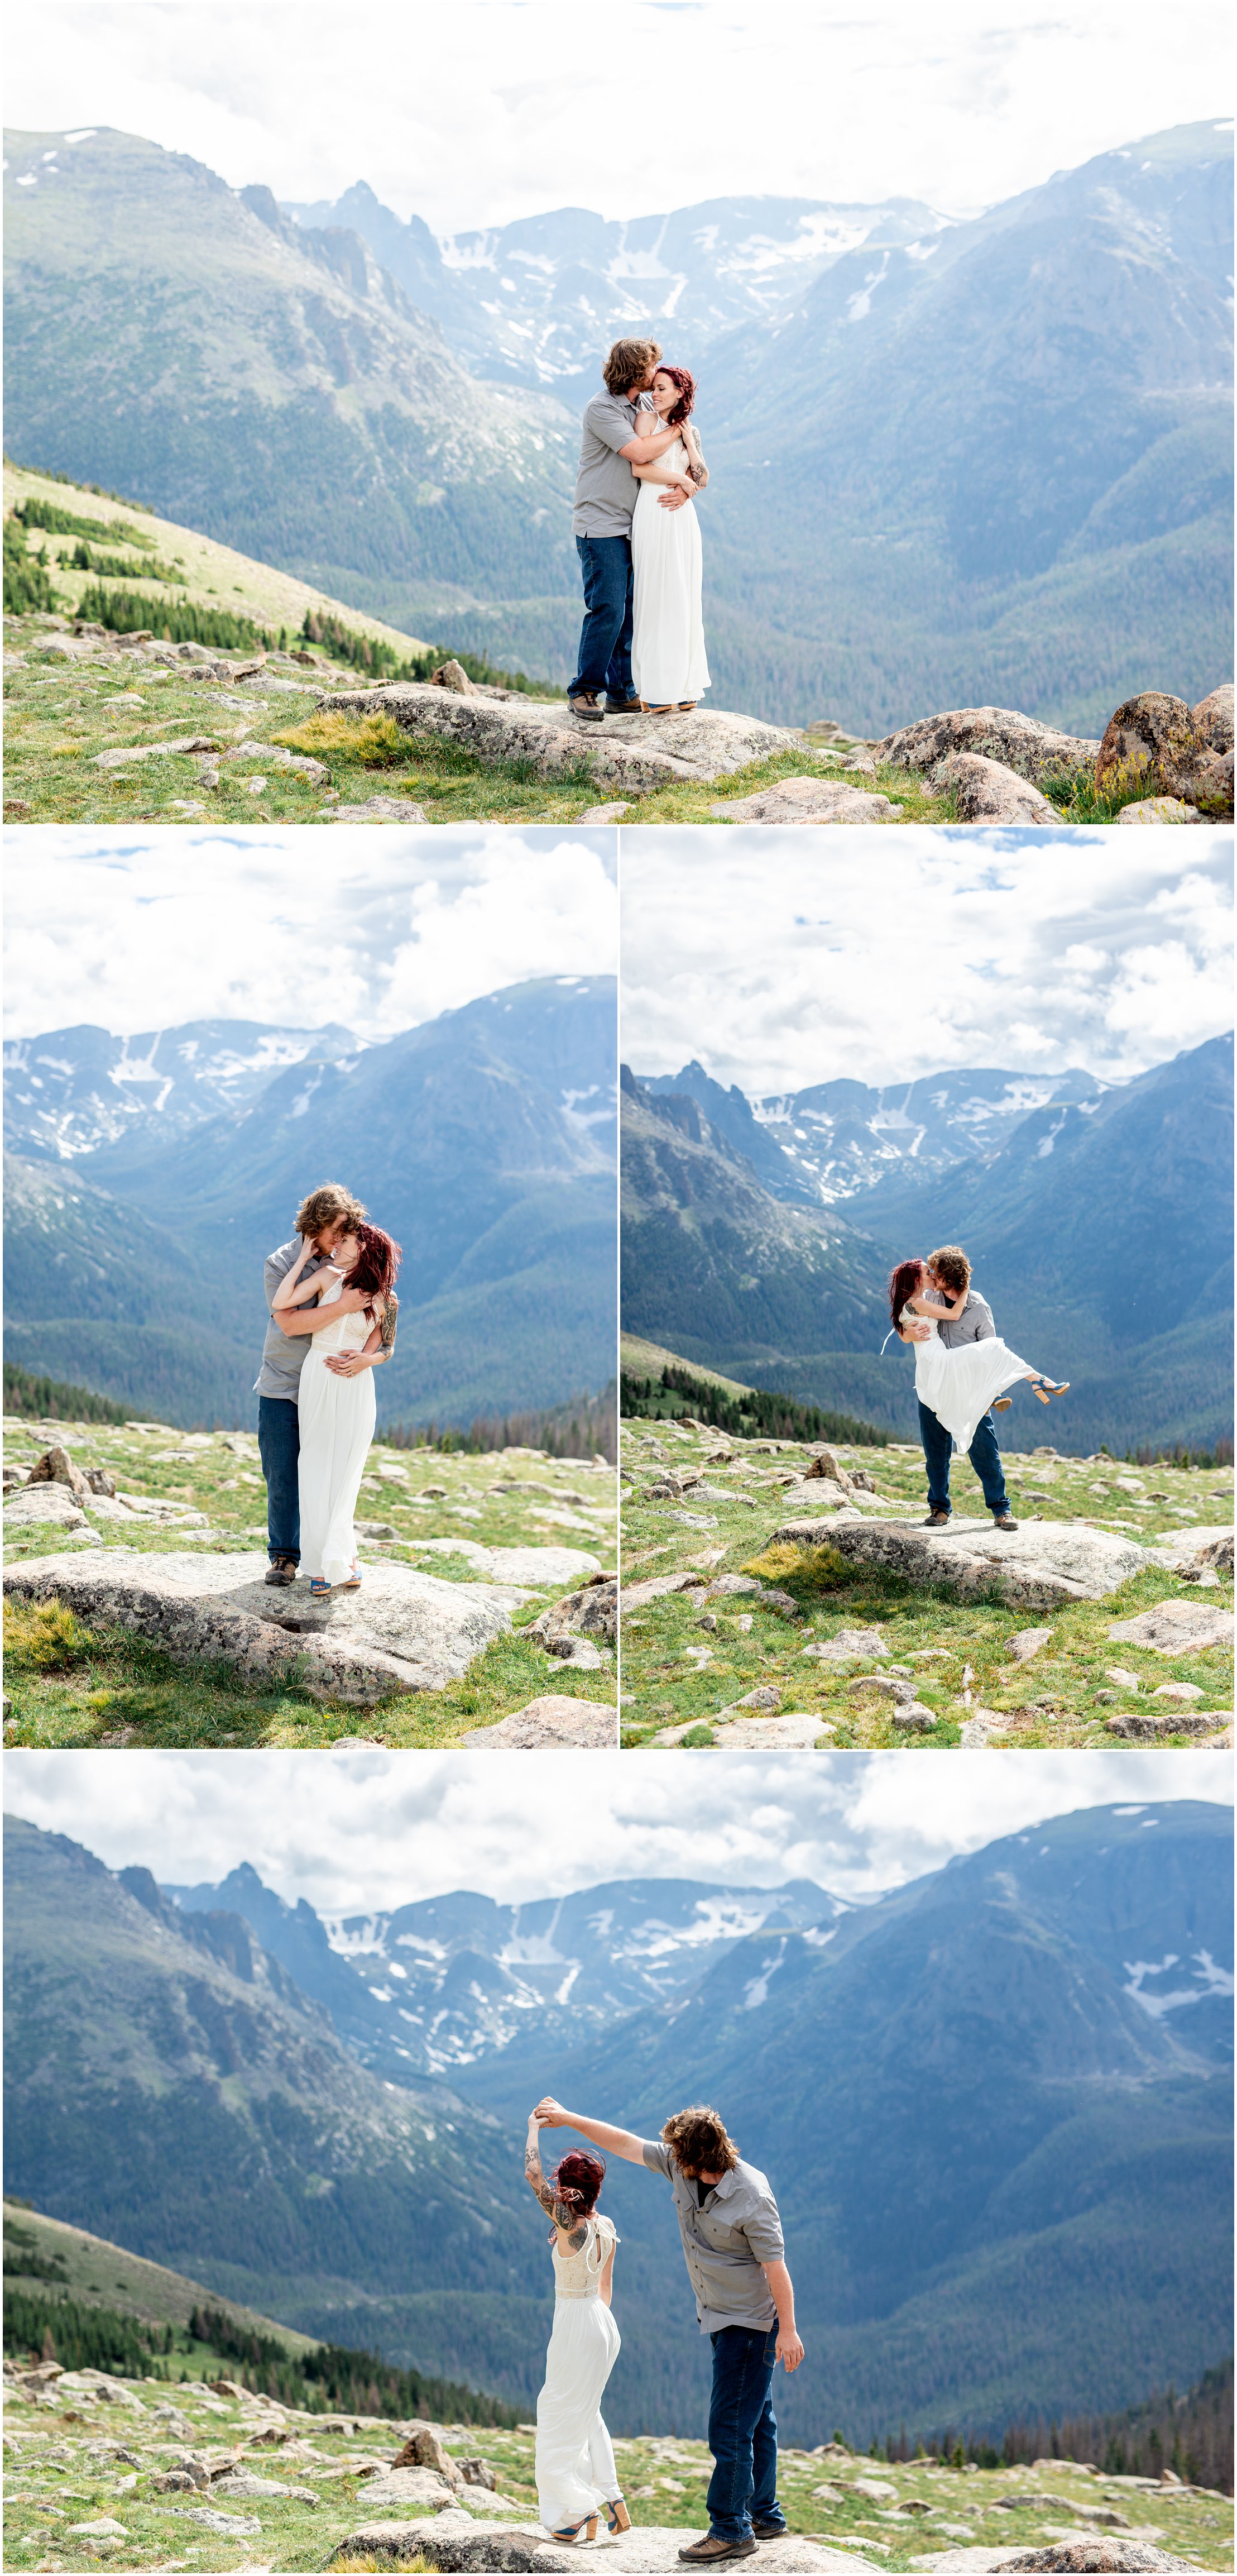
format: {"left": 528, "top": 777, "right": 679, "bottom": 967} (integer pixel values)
{"left": 255, "top": 1180, "right": 402, "bottom": 1600}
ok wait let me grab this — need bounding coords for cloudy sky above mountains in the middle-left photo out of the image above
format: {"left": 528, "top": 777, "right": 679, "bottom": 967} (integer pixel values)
{"left": 5, "top": 824, "right": 618, "bottom": 1038}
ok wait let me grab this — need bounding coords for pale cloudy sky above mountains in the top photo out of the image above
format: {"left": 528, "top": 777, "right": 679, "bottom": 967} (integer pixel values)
{"left": 8, "top": 0, "right": 1232, "bottom": 232}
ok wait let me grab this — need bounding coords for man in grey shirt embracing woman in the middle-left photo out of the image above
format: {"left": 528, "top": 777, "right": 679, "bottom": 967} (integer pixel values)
{"left": 255, "top": 1180, "right": 366, "bottom": 1584}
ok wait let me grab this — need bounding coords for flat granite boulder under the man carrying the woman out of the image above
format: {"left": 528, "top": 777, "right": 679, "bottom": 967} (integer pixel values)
{"left": 768, "top": 1512, "right": 1154, "bottom": 1610}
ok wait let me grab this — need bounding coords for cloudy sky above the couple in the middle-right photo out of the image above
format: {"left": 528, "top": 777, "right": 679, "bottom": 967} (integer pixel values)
{"left": 621, "top": 827, "right": 1232, "bottom": 1095}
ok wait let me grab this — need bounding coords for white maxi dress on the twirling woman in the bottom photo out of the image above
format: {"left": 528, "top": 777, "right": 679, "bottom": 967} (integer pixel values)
{"left": 536, "top": 2218, "right": 621, "bottom": 2532}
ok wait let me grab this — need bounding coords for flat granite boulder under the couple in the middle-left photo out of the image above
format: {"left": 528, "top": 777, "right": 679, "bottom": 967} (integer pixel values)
{"left": 5, "top": 1548, "right": 526, "bottom": 1705}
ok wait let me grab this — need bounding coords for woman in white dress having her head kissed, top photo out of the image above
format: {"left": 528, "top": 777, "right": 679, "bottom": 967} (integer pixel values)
{"left": 631, "top": 366, "right": 709, "bottom": 716}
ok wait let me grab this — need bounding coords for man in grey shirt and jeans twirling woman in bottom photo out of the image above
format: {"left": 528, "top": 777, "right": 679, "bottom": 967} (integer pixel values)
{"left": 536, "top": 2094, "right": 804, "bottom": 2566}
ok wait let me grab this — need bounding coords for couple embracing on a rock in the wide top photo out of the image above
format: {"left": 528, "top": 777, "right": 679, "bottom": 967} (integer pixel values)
{"left": 567, "top": 340, "right": 709, "bottom": 724}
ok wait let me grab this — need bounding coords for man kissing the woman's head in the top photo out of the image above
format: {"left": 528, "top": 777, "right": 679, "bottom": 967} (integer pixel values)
{"left": 567, "top": 340, "right": 688, "bottom": 724}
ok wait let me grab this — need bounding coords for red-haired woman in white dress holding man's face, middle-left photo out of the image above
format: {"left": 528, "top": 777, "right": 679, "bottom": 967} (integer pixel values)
{"left": 271, "top": 1226, "right": 402, "bottom": 1600}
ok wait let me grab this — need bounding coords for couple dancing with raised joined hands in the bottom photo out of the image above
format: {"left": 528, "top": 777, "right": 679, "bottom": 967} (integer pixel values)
{"left": 523, "top": 2094, "right": 804, "bottom": 2566}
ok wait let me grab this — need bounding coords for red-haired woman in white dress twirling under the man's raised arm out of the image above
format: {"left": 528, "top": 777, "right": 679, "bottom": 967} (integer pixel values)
{"left": 523, "top": 2110, "right": 631, "bottom": 2542}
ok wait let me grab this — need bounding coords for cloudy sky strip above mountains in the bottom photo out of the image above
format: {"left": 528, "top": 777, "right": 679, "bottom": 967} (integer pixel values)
{"left": 5, "top": 1747, "right": 1232, "bottom": 1914}
